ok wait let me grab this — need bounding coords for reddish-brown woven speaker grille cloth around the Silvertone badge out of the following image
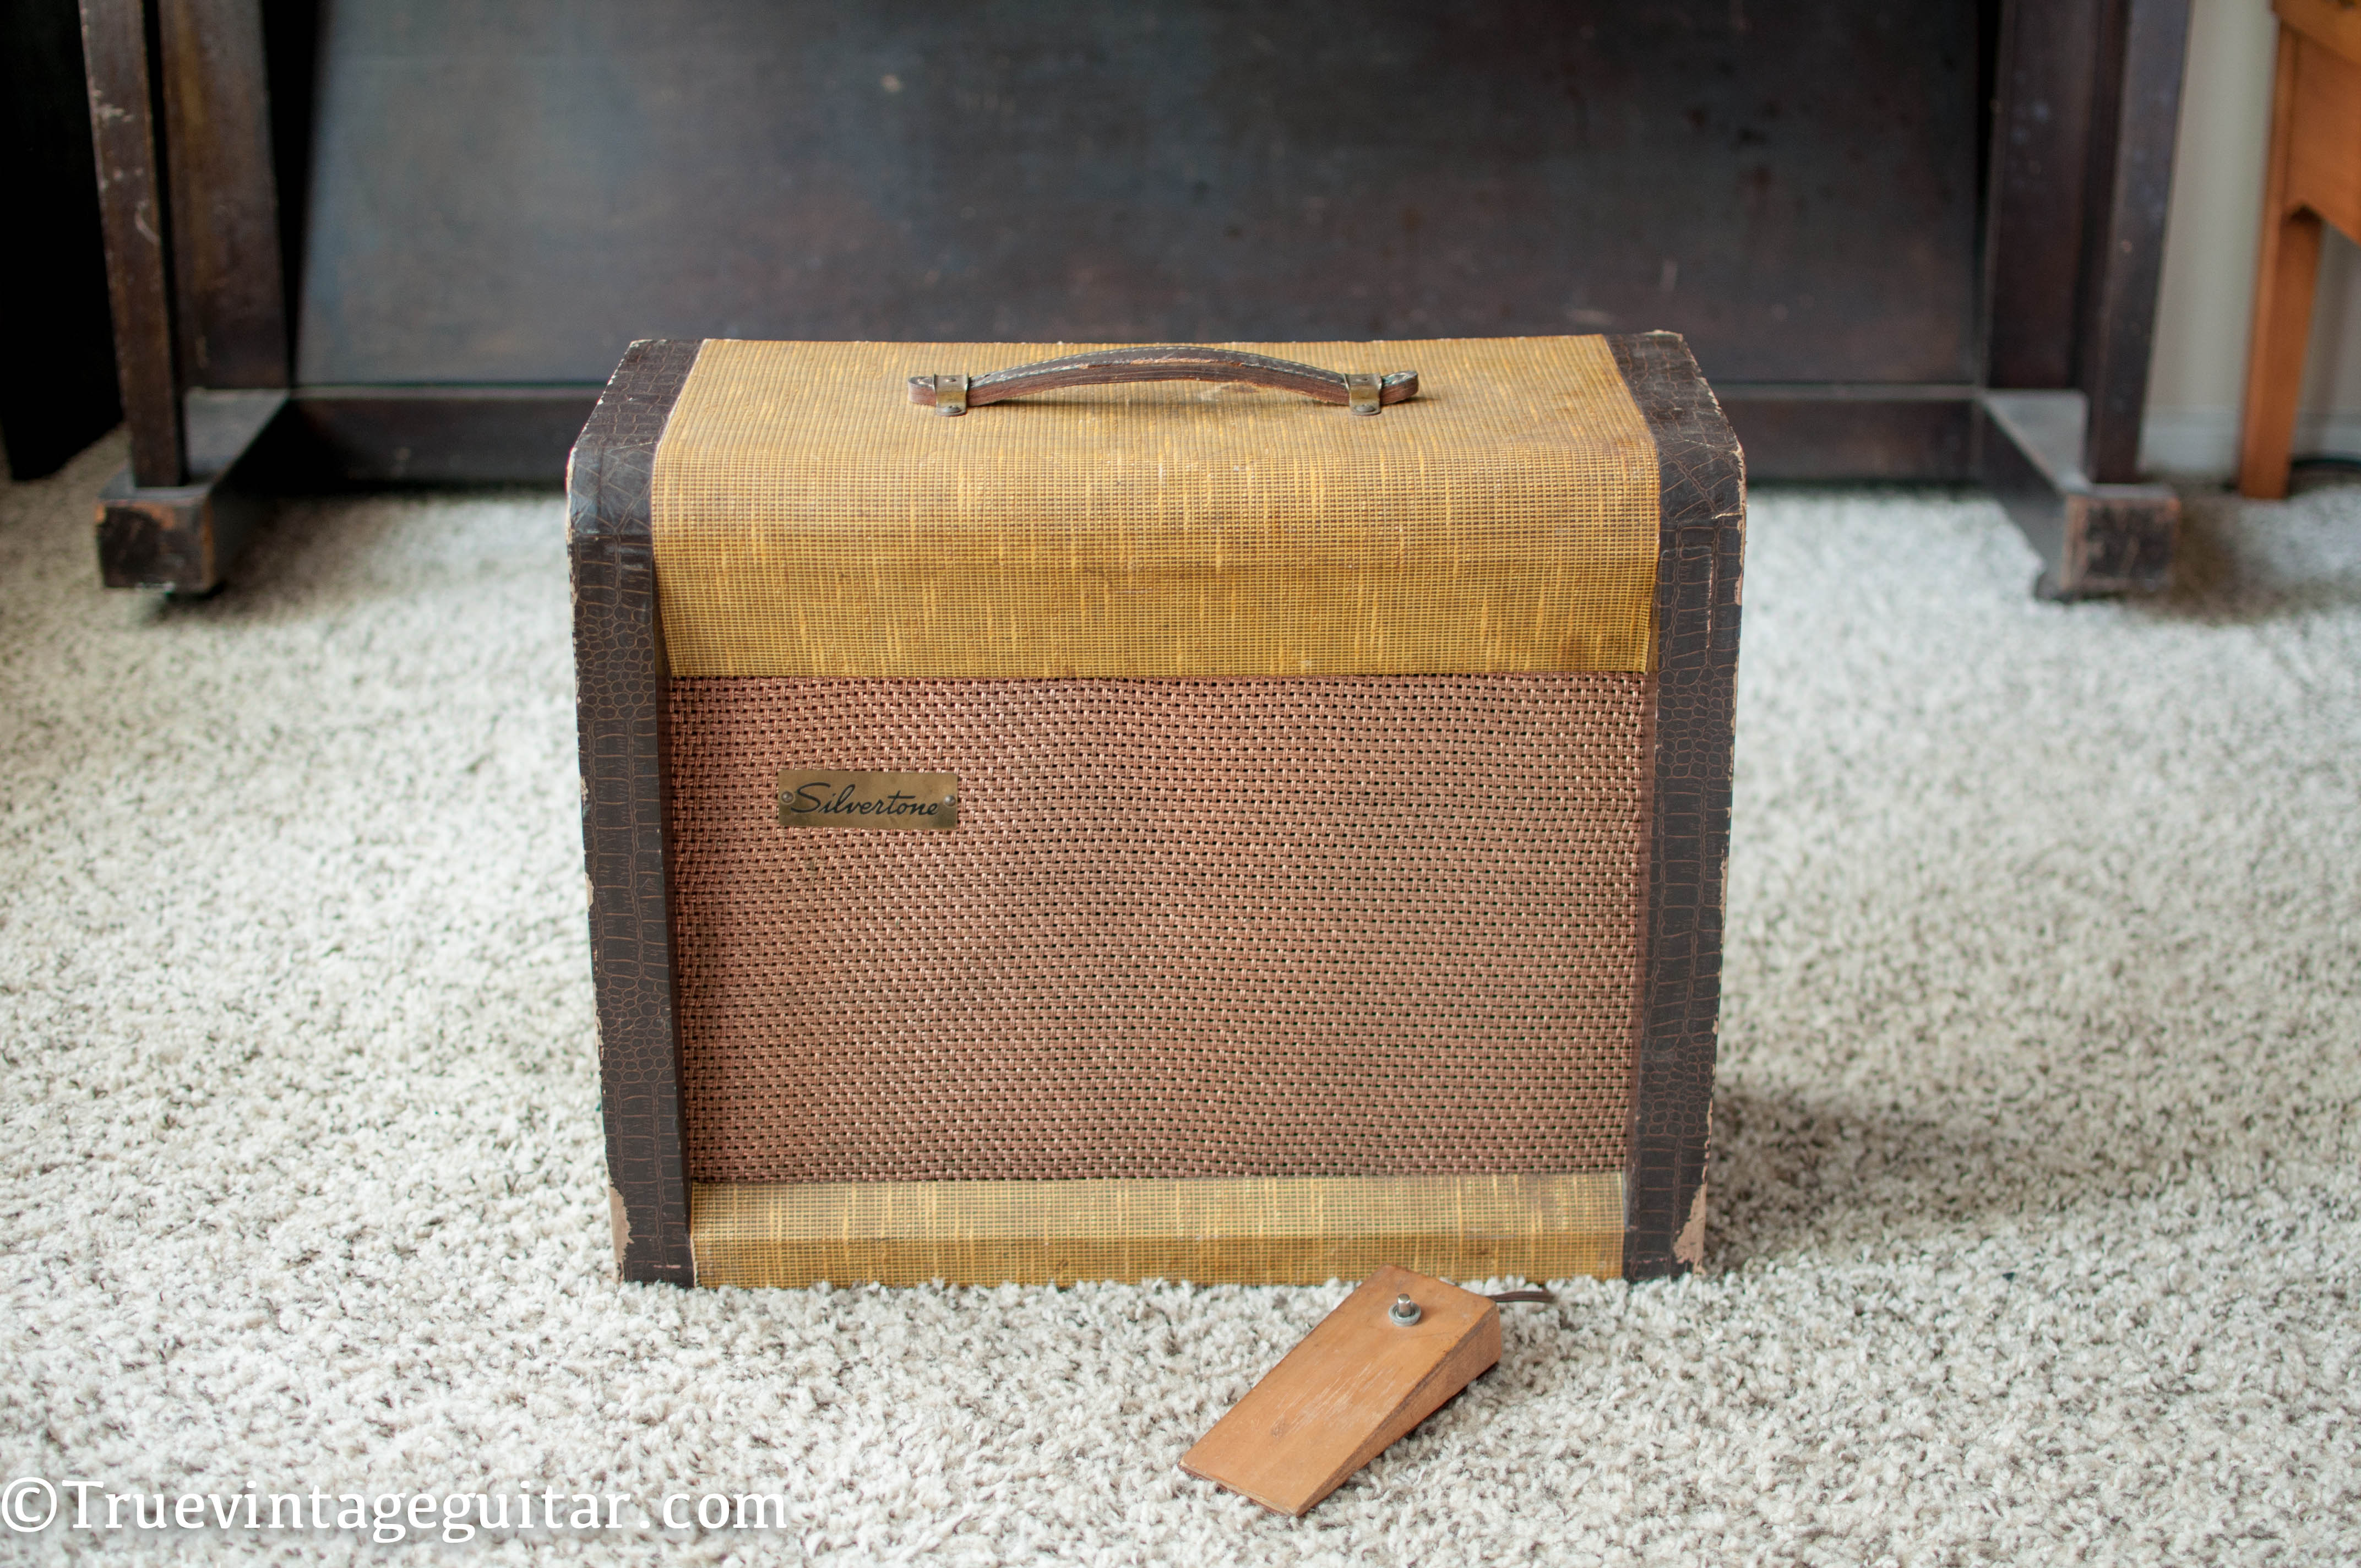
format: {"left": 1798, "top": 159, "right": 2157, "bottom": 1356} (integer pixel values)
{"left": 671, "top": 673, "right": 1650, "bottom": 1183}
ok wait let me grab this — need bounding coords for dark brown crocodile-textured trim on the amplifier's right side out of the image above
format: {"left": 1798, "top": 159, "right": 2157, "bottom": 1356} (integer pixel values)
{"left": 1610, "top": 333, "right": 1747, "bottom": 1280}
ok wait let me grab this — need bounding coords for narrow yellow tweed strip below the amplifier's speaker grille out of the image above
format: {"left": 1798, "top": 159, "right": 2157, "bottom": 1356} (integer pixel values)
{"left": 689, "top": 1171, "right": 1624, "bottom": 1284}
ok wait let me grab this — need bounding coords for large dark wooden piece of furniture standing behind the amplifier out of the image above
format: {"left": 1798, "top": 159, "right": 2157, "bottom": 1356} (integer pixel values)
{"left": 83, "top": 0, "right": 2186, "bottom": 595}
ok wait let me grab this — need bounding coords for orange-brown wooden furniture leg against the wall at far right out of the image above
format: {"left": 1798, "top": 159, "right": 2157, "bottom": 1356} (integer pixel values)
{"left": 2238, "top": 26, "right": 2321, "bottom": 500}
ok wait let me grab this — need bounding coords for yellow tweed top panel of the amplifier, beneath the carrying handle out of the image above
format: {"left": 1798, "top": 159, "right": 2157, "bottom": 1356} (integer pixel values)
{"left": 651, "top": 337, "right": 1657, "bottom": 678}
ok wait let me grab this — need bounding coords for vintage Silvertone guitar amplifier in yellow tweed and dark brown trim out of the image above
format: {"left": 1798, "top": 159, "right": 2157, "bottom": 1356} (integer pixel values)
{"left": 569, "top": 333, "right": 1745, "bottom": 1284}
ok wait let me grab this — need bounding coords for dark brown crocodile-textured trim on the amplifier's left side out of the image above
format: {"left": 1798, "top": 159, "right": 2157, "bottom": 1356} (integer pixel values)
{"left": 567, "top": 342, "right": 699, "bottom": 1284}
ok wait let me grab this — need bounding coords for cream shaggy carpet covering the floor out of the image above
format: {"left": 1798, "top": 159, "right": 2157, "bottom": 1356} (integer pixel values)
{"left": 0, "top": 442, "right": 2361, "bottom": 1563}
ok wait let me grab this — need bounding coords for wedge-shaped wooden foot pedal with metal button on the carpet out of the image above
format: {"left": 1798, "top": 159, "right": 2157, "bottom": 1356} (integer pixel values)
{"left": 1180, "top": 1266, "right": 1499, "bottom": 1513}
